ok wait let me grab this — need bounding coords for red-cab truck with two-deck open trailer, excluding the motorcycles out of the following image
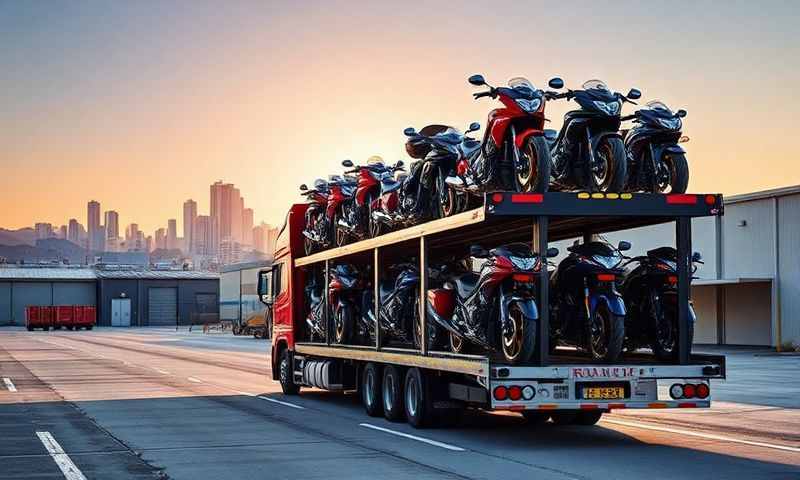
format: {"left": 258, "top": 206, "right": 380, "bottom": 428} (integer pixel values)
{"left": 259, "top": 192, "right": 725, "bottom": 427}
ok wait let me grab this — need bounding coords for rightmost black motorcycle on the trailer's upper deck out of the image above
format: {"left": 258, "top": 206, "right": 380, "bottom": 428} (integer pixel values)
{"left": 621, "top": 100, "right": 689, "bottom": 193}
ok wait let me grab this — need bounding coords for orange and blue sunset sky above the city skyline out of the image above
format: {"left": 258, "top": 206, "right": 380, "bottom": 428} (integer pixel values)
{"left": 0, "top": 0, "right": 800, "bottom": 233}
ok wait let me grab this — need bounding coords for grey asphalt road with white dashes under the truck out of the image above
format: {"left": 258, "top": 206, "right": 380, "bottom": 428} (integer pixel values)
{"left": 0, "top": 329, "right": 800, "bottom": 480}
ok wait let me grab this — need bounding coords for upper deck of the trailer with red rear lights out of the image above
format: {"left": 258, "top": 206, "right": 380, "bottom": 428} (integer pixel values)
{"left": 295, "top": 192, "right": 723, "bottom": 266}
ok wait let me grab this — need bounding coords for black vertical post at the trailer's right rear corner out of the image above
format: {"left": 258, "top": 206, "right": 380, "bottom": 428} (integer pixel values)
{"left": 675, "top": 217, "right": 692, "bottom": 365}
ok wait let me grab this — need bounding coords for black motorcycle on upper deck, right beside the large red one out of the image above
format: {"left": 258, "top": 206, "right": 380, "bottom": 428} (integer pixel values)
{"left": 544, "top": 80, "right": 642, "bottom": 192}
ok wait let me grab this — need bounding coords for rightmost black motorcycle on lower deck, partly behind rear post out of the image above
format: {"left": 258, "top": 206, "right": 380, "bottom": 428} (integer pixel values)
{"left": 621, "top": 247, "right": 703, "bottom": 361}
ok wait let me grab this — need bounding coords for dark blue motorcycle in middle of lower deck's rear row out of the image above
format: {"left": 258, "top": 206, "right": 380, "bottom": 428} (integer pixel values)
{"left": 550, "top": 241, "right": 631, "bottom": 362}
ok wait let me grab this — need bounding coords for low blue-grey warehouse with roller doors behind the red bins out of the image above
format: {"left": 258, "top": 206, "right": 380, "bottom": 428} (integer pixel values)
{"left": 0, "top": 267, "right": 219, "bottom": 327}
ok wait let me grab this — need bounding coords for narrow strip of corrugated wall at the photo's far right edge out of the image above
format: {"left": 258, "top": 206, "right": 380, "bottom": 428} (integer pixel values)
{"left": 778, "top": 195, "right": 800, "bottom": 344}
